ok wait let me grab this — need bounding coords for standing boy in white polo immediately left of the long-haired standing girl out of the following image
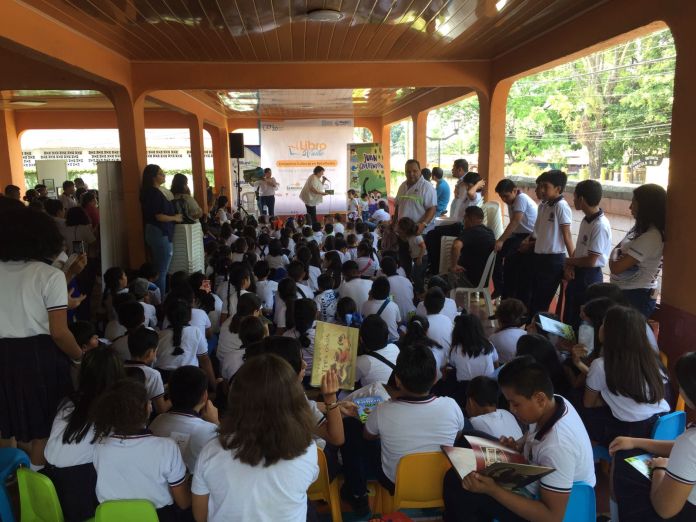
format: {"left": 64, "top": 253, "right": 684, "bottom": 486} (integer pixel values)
{"left": 563, "top": 179, "right": 611, "bottom": 329}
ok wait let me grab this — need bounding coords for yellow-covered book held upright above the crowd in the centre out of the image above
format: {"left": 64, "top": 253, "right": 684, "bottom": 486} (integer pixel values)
{"left": 311, "top": 321, "right": 359, "bottom": 390}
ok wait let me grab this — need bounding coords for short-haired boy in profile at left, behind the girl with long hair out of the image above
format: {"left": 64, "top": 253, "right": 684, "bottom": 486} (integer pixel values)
{"left": 123, "top": 326, "right": 171, "bottom": 413}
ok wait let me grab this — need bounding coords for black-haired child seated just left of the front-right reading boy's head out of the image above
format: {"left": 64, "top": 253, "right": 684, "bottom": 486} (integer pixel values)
{"left": 466, "top": 375, "right": 522, "bottom": 440}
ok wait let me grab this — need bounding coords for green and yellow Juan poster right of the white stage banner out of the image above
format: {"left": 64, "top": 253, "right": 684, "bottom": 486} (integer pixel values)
{"left": 348, "top": 143, "right": 387, "bottom": 206}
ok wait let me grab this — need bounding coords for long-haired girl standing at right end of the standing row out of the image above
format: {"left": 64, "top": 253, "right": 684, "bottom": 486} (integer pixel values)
{"left": 609, "top": 184, "right": 667, "bottom": 317}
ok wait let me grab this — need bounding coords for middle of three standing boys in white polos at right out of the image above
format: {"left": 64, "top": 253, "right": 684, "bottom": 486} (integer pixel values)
{"left": 522, "top": 170, "right": 573, "bottom": 317}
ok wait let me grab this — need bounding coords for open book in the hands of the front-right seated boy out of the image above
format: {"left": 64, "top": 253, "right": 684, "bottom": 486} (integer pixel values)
{"left": 441, "top": 437, "right": 554, "bottom": 489}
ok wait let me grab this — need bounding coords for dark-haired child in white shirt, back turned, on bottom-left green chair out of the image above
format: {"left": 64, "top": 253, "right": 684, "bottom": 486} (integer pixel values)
{"left": 90, "top": 379, "right": 191, "bottom": 522}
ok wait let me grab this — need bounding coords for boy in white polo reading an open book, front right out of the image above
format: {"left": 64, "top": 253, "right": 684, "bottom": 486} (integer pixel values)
{"left": 443, "top": 357, "right": 595, "bottom": 522}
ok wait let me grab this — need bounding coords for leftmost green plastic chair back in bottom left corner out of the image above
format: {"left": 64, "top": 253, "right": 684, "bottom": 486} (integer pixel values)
{"left": 17, "top": 468, "right": 64, "bottom": 522}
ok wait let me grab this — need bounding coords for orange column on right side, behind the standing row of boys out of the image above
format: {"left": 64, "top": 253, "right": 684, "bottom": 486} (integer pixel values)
{"left": 478, "top": 80, "right": 512, "bottom": 200}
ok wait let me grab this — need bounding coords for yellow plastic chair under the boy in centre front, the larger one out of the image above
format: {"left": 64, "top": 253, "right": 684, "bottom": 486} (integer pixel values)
{"left": 375, "top": 451, "right": 451, "bottom": 513}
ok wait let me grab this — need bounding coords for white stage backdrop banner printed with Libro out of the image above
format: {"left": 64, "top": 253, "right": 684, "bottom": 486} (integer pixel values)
{"left": 261, "top": 119, "right": 353, "bottom": 215}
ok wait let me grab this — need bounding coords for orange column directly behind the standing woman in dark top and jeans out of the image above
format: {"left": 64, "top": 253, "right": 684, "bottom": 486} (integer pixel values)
{"left": 111, "top": 88, "right": 147, "bottom": 268}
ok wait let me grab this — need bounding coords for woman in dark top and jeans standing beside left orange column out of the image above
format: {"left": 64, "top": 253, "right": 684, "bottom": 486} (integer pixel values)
{"left": 140, "top": 165, "right": 182, "bottom": 295}
